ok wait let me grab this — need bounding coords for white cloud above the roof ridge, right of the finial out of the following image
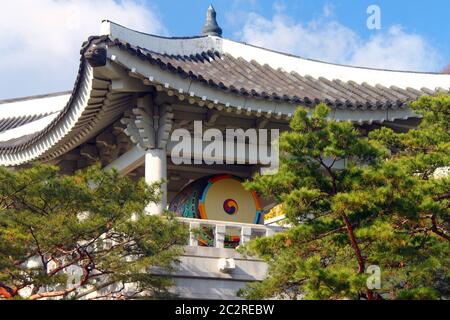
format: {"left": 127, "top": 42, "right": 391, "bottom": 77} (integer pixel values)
{"left": 237, "top": 6, "right": 442, "bottom": 71}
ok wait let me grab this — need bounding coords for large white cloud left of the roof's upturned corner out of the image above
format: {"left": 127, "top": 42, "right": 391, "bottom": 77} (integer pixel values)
{"left": 0, "top": 0, "right": 166, "bottom": 99}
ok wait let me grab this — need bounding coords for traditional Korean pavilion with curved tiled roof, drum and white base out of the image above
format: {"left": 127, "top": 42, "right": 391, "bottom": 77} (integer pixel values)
{"left": 0, "top": 7, "right": 450, "bottom": 298}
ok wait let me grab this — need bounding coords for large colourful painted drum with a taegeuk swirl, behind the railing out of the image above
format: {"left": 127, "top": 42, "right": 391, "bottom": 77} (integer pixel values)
{"left": 169, "top": 175, "right": 262, "bottom": 223}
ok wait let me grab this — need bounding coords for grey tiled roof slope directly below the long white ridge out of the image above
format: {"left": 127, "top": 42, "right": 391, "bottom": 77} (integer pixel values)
{"left": 114, "top": 39, "right": 442, "bottom": 109}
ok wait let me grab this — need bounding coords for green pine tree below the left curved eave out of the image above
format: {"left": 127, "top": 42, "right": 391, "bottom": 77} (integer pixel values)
{"left": 0, "top": 165, "right": 187, "bottom": 300}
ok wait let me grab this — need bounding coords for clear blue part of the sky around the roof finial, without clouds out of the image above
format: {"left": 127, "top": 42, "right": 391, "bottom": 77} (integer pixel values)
{"left": 156, "top": 0, "right": 450, "bottom": 60}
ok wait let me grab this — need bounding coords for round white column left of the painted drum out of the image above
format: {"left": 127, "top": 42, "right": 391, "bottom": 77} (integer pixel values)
{"left": 145, "top": 149, "right": 167, "bottom": 214}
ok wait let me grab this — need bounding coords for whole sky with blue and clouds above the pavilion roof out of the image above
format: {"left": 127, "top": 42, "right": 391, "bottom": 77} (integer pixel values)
{"left": 0, "top": 0, "right": 450, "bottom": 99}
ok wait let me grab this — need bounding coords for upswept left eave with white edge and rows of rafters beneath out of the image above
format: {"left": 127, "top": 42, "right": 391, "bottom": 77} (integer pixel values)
{"left": 0, "top": 37, "right": 132, "bottom": 166}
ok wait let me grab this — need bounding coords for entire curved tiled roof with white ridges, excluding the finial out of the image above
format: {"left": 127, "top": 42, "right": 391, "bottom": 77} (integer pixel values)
{"left": 0, "top": 21, "right": 450, "bottom": 165}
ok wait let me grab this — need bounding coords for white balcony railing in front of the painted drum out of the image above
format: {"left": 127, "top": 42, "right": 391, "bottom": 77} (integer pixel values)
{"left": 180, "top": 218, "right": 283, "bottom": 249}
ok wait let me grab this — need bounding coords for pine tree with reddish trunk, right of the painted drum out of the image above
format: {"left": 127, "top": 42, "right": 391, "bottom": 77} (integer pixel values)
{"left": 240, "top": 95, "right": 450, "bottom": 299}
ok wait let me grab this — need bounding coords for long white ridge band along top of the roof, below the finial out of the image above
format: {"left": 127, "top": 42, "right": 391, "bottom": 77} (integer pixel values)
{"left": 101, "top": 20, "right": 450, "bottom": 90}
